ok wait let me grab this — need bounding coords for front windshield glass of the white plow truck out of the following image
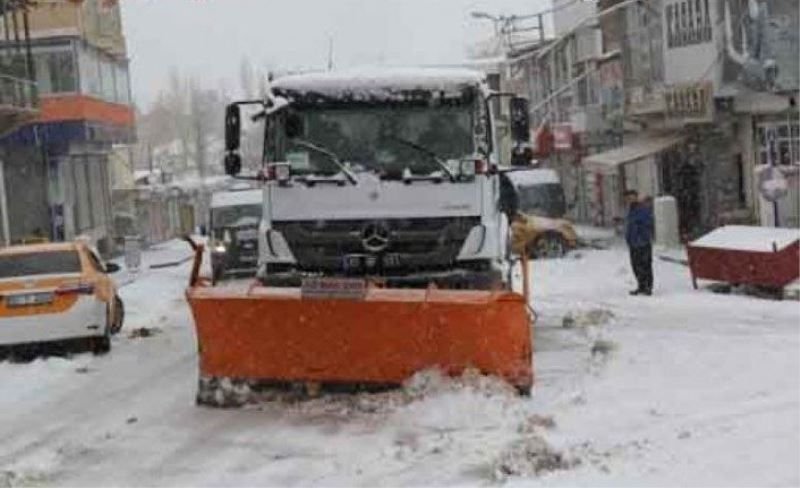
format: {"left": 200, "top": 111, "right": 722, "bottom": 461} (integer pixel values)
{"left": 285, "top": 106, "right": 474, "bottom": 178}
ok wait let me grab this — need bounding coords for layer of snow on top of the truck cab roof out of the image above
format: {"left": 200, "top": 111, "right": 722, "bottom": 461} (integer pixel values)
{"left": 272, "top": 68, "right": 484, "bottom": 98}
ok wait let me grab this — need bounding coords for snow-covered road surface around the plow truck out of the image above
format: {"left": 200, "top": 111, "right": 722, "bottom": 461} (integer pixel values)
{"left": 0, "top": 243, "right": 800, "bottom": 487}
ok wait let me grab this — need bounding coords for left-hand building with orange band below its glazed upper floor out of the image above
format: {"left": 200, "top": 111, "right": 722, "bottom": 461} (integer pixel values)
{"left": 0, "top": 0, "right": 135, "bottom": 252}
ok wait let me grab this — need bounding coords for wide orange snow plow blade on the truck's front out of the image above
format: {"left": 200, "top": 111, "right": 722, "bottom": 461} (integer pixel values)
{"left": 181, "top": 236, "right": 533, "bottom": 400}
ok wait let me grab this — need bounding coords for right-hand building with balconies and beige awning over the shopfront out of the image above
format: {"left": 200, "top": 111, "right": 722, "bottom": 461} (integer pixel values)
{"left": 585, "top": 0, "right": 800, "bottom": 239}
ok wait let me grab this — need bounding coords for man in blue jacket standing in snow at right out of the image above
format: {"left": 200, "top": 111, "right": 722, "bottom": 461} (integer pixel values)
{"left": 625, "top": 190, "right": 653, "bottom": 295}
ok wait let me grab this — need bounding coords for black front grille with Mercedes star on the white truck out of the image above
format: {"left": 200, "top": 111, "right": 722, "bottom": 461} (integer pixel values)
{"left": 273, "top": 217, "right": 480, "bottom": 274}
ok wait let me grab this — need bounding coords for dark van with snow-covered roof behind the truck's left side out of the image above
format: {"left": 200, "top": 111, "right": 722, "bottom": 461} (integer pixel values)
{"left": 209, "top": 189, "right": 263, "bottom": 282}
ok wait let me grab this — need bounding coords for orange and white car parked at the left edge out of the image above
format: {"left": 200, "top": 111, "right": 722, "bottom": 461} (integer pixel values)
{"left": 0, "top": 240, "right": 125, "bottom": 354}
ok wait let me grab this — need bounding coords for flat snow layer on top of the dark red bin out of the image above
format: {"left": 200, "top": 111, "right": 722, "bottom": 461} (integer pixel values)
{"left": 690, "top": 225, "right": 800, "bottom": 252}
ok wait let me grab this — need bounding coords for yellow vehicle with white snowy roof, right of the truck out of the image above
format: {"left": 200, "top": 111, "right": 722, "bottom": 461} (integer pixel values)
{"left": 501, "top": 168, "right": 578, "bottom": 258}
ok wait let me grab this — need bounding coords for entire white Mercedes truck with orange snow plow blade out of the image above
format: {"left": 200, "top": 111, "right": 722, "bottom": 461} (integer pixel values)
{"left": 186, "top": 69, "right": 533, "bottom": 406}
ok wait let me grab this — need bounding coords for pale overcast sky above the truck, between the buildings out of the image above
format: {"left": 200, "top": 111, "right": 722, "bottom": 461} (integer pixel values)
{"left": 121, "top": 0, "right": 550, "bottom": 108}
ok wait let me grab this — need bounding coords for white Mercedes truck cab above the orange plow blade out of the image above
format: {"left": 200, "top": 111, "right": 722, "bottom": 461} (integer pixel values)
{"left": 226, "top": 69, "right": 536, "bottom": 289}
